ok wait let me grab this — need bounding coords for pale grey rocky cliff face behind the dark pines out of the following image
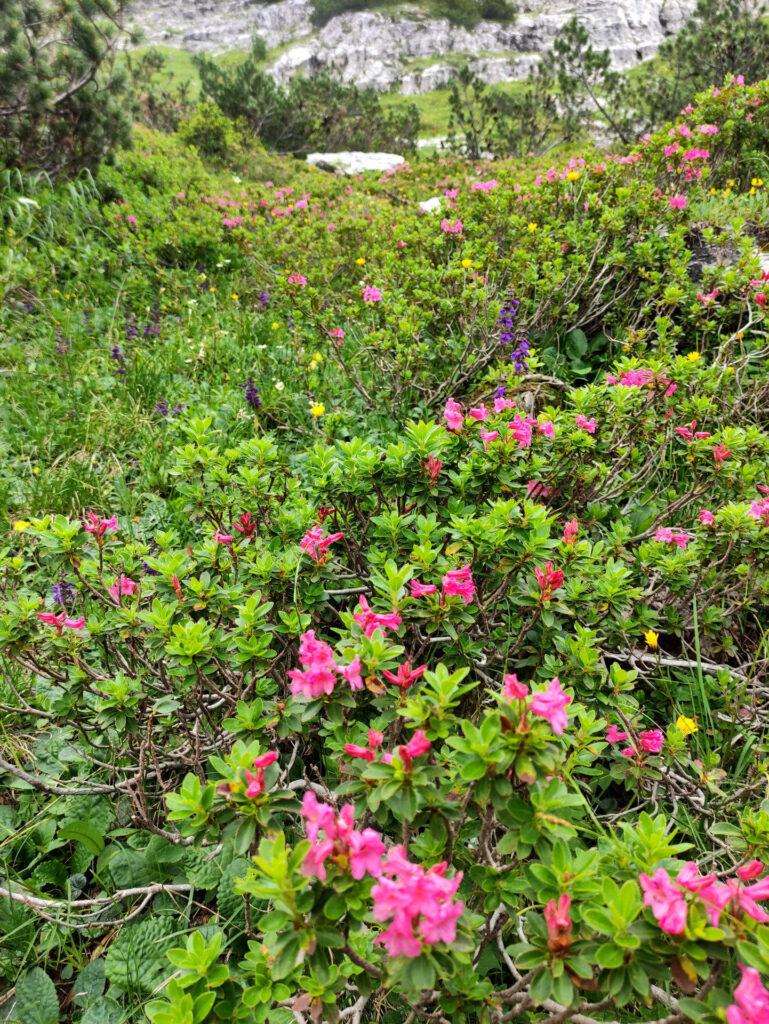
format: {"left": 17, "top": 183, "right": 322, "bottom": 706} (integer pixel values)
{"left": 127, "top": 0, "right": 695, "bottom": 93}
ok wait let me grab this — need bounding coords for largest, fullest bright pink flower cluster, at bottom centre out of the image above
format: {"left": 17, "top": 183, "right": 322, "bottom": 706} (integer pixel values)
{"left": 371, "top": 846, "right": 464, "bottom": 957}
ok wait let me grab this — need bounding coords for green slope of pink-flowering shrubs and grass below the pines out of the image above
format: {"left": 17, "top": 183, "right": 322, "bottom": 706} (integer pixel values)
{"left": 0, "top": 66, "right": 769, "bottom": 1024}
